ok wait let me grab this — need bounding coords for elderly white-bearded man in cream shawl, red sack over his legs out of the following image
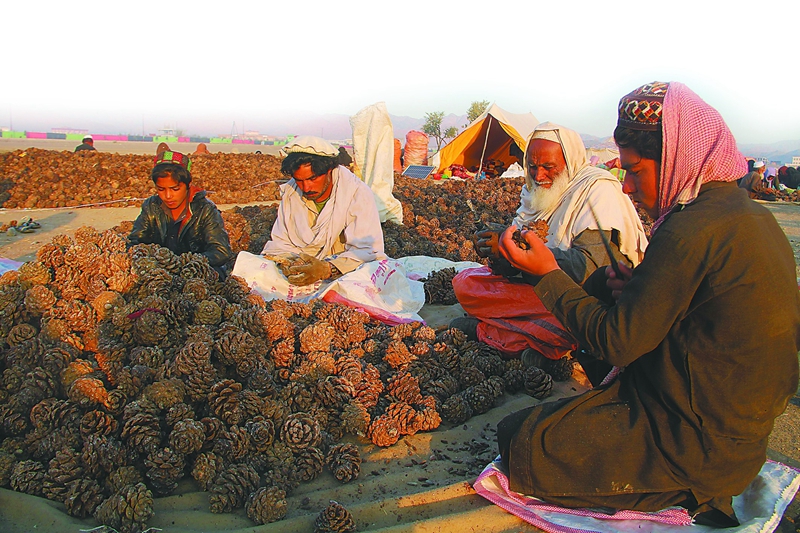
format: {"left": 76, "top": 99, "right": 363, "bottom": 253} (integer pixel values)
{"left": 450, "top": 122, "right": 647, "bottom": 363}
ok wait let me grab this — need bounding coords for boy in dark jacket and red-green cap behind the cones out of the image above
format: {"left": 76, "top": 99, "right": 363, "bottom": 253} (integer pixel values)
{"left": 128, "top": 150, "right": 233, "bottom": 276}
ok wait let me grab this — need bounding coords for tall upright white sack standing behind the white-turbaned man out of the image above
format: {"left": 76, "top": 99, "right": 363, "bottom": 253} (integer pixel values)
{"left": 350, "top": 102, "right": 403, "bottom": 224}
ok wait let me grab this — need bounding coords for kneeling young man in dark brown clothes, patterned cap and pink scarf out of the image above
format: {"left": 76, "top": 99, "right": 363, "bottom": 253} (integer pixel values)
{"left": 497, "top": 82, "right": 800, "bottom": 527}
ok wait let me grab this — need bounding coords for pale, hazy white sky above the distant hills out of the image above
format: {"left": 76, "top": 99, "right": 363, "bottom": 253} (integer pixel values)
{"left": 0, "top": 0, "right": 800, "bottom": 143}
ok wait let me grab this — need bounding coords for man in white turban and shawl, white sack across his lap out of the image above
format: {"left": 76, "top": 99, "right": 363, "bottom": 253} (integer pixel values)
{"left": 233, "top": 136, "right": 425, "bottom": 322}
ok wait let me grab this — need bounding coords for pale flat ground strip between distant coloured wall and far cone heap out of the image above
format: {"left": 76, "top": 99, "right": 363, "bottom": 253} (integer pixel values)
{"left": 0, "top": 138, "right": 281, "bottom": 155}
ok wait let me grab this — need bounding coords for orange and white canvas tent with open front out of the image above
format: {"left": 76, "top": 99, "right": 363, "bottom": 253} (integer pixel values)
{"left": 436, "top": 104, "right": 539, "bottom": 172}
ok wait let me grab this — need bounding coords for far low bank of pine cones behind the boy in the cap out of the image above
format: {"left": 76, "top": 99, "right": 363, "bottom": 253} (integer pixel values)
{"left": 0, "top": 148, "right": 285, "bottom": 209}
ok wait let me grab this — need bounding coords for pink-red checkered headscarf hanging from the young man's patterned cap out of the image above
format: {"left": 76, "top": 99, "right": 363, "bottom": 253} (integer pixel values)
{"left": 653, "top": 82, "right": 747, "bottom": 231}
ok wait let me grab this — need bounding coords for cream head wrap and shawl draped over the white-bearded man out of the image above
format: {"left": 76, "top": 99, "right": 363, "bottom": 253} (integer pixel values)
{"left": 514, "top": 122, "right": 647, "bottom": 265}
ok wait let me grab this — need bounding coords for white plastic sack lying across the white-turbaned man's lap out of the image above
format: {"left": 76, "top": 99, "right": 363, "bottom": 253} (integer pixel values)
{"left": 232, "top": 252, "right": 425, "bottom": 325}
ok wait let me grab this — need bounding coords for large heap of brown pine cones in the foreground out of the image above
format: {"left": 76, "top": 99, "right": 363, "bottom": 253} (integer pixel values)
{"left": 0, "top": 227, "right": 571, "bottom": 532}
